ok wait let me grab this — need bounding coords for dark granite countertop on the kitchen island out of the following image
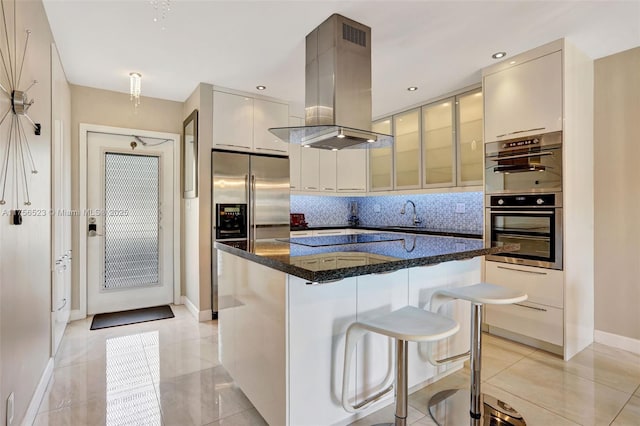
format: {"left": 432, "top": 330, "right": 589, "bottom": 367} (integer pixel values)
{"left": 215, "top": 233, "right": 520, "bottom": 282}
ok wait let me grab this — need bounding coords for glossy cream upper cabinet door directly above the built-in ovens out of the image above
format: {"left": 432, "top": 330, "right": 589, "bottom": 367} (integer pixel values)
{"left": 483, "top": 52, "right": 562, "bottom": 142}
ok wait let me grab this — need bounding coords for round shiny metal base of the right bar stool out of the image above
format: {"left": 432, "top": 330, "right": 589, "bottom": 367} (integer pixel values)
{"left": 429, "top": 389, "right": 527, "bottom": 426}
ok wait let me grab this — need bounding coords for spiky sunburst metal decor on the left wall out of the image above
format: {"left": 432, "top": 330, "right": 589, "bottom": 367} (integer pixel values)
{"left": 0, "top": 0, "right": 40, "bottom": 221}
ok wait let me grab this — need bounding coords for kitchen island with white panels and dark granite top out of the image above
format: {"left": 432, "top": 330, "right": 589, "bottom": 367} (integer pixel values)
{"left": 215, "top": 233, "right": 518, "bottom": 426}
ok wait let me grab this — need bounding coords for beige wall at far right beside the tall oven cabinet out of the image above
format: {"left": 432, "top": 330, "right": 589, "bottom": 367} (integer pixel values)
{"left": 594, "top": 47, "right": 640, "bottom": 339}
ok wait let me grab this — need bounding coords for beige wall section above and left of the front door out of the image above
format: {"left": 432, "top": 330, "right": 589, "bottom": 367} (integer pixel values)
{"left": 71, "top": 84, "right": 183, "bottom": 309}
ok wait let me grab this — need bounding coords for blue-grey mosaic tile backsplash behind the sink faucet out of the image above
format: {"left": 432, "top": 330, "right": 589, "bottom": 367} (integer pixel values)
{"left": 291, "top": 192, "right": 483, "bottom": 234}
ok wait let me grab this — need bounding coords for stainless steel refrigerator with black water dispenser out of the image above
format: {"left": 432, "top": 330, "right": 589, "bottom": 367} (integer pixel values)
{"left": 211, "top": 149, "right": 290, "bottom": 318}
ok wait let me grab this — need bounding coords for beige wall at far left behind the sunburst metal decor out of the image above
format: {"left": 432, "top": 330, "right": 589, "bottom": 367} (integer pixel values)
{"left": 0, "top": 1, "right": 59, "bottom": 424}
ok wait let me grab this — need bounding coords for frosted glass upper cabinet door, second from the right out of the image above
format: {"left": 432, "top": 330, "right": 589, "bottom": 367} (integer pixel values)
{"left": 422, "top": 98, "right": 455, "bottom": 188}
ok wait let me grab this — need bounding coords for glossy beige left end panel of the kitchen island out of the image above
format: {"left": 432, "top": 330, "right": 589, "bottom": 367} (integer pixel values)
{"left": 218, "top": 251, "right": 287, "bottom": 425}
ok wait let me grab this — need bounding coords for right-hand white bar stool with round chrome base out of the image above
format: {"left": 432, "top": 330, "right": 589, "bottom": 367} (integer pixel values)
{"left": 429, "top": 283, "right": 528, "bottom": 426}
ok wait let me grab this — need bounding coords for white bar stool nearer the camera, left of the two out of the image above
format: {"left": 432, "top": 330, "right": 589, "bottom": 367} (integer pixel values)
{"left": 342, "top": 306, "right": 460, "bottom": 426}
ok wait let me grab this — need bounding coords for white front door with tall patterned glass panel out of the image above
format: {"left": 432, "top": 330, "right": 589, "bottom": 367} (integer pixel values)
{"left": 87, "top": 132, "right": 175, "bottom": 315}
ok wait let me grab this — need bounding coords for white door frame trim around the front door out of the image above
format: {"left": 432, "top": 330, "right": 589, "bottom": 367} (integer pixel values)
{"left": 79, "top": 123, "right": 182, "bottom": 320}
